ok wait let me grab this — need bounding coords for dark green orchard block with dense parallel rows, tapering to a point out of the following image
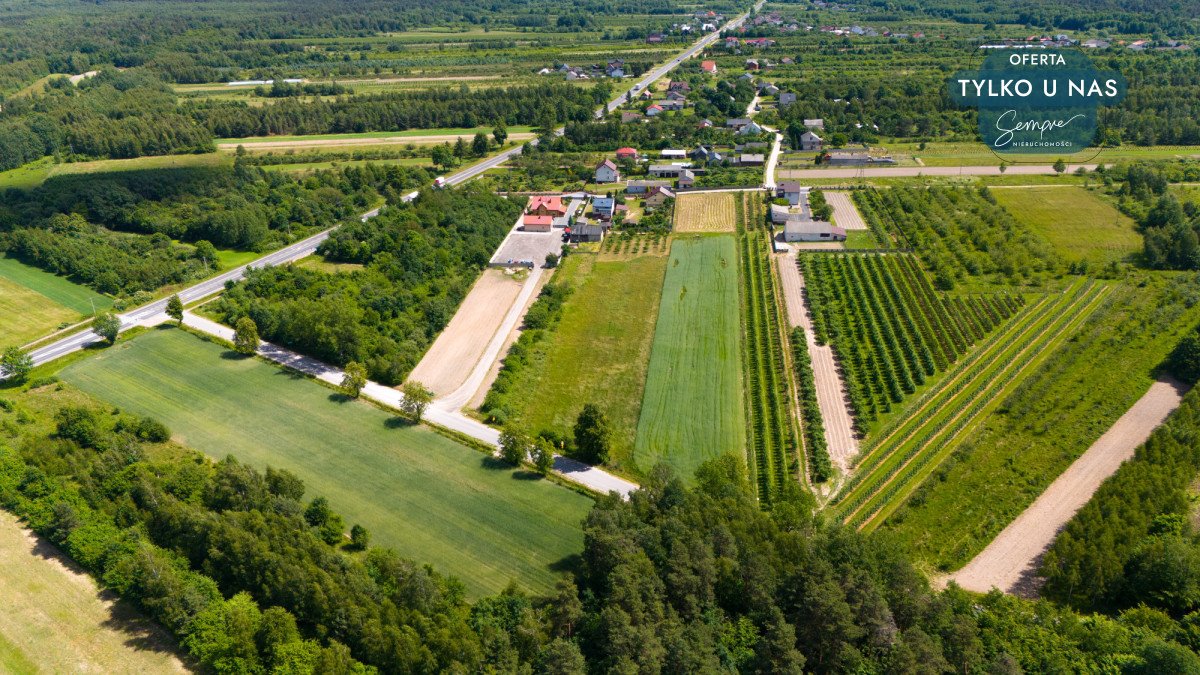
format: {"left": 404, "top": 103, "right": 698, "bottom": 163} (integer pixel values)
{"left": 800, "top": 253, "right": 1024, "bottom": 434}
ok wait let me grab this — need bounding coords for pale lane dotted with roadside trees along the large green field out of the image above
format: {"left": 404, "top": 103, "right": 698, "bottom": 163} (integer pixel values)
{"left": 178, "top": 312, "right": 638, "bottom": 497}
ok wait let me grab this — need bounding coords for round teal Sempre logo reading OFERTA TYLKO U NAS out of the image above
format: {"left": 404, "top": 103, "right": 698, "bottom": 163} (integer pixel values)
{"left": 947, "top": 49, "right": 1126, "bottom": 154}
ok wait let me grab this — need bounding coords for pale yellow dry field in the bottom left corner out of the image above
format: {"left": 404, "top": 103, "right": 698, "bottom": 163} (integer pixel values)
{"left": 0, "top": 512, "right": 190, "bottom": 674}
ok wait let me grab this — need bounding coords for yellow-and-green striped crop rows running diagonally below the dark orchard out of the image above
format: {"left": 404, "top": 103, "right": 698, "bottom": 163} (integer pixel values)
{"left": 836, "top": 276, "right": 1108, "bottom": 528}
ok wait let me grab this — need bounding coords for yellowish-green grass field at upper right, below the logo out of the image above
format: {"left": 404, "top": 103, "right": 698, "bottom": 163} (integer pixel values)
{"left": 991, "top": 186, "right": 1141, "bottom": 263}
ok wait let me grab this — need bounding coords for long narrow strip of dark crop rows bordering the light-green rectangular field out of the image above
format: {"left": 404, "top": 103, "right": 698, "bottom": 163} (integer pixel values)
{"left": 736, "top": 190, "right": 797, "bottom": 502}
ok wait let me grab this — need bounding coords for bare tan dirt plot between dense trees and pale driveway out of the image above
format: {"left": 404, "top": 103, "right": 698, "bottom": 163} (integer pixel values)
{"left": 409, "top": 269, "right": 522, "bottom": 396}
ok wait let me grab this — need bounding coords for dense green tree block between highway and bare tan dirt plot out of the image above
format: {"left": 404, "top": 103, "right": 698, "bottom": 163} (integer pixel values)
{"left": 216, "top": 186, "right": 522, "bottom": 384}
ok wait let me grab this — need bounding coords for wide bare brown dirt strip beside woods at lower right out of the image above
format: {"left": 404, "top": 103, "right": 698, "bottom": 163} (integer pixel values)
{"left": 940, "top": 378, "right": 1187, "bottom": 597}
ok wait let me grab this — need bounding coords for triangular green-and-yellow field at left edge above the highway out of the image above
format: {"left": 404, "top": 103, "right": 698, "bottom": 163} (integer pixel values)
{"left": 0, "top": 256, "right": 113, "bottom": 348}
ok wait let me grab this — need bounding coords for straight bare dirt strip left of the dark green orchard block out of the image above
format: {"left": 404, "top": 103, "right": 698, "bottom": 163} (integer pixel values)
{"left": 776, "top": 255, "right": 858, "bottom": 471}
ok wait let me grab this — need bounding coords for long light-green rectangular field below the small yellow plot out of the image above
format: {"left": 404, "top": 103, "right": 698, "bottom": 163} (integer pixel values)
{"left": 634, "top": 235, "right": 745, "bottom": 478}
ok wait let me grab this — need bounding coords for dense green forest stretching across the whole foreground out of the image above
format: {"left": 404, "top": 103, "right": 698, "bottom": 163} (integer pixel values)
{"left": 0, "top": 383, "right": 1200, "bottom": 674}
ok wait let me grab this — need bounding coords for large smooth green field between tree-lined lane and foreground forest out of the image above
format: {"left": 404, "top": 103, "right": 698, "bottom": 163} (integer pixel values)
{"left": 61, "top": 329, "right": 592, "bottom": 597}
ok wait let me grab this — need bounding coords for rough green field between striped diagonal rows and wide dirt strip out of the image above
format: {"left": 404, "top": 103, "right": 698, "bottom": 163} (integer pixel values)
{"left": 882, "top": 273, "right": 1200, "bottom": 572}
